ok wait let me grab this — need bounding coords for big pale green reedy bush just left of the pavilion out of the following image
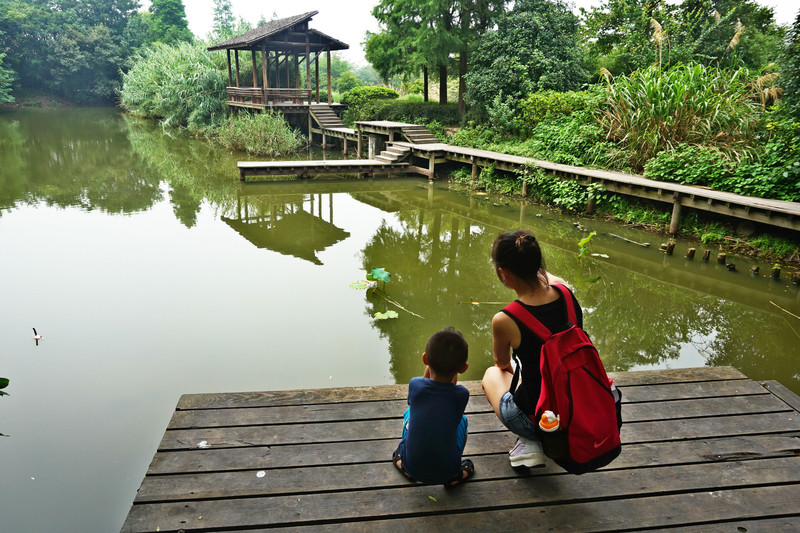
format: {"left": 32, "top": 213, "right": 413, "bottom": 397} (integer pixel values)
{"left": 120, "top": 43, "right": 227, "bottom": 131}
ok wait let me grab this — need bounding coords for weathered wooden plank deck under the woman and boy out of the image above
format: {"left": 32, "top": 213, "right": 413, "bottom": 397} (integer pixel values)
{"left": 122, "top": 367, "right": 800, "bottom": 533}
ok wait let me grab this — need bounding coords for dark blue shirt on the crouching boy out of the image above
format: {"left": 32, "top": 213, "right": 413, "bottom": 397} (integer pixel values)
{"left": 399, "top": 377, "right": 469, "bottom": 483}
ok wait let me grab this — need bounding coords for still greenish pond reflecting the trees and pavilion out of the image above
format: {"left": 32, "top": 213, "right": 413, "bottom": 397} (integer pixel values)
{"left": 0, "top": 109, "right": 800, "bottom": 532}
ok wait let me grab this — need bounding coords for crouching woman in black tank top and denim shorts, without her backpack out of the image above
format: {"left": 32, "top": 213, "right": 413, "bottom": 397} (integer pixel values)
{"left": 482, "top": 230, "right": 583, "bottom": 467}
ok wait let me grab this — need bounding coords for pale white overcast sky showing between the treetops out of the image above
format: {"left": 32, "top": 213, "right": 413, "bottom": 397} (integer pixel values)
{"left": 147, "top": 0, "right": 800, "bottom": 65}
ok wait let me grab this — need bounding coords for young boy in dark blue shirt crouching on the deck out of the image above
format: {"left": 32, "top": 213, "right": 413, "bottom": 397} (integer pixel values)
{"left": 392, "top": 327, "right": 475, "bottom": 487}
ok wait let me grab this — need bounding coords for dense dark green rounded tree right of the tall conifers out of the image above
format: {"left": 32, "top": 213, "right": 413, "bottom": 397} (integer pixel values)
{"left": 466, "top": 0, "right": 588, "bottom": 119}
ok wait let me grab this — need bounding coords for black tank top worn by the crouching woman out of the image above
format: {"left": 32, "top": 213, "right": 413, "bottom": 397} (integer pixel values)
{"left": 503, "top": 289, "right": 583, "bottom": 415}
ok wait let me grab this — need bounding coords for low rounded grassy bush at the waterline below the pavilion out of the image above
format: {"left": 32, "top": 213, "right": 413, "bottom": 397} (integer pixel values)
{"left": 211, "top": 111, "right": 303, "bottom": 156}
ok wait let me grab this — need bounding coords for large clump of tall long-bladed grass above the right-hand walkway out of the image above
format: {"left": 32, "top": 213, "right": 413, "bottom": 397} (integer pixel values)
{"left": 598, "top": 64, "right": 758, "bottom": 170}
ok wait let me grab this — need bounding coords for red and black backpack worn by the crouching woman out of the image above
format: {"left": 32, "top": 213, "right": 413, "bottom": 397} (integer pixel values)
{"left": 505, "top": 284, "right": 622, "bottom": 474}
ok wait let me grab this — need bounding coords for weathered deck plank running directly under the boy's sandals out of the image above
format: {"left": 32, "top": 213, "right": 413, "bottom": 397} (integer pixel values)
{"left": 131, "top": 435, "right": 800, "bottom": 503}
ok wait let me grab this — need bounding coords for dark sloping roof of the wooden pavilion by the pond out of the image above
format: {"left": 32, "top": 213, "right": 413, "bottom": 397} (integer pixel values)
{"left": 208, "top": 11, "right": 350, "bottom": 51}
